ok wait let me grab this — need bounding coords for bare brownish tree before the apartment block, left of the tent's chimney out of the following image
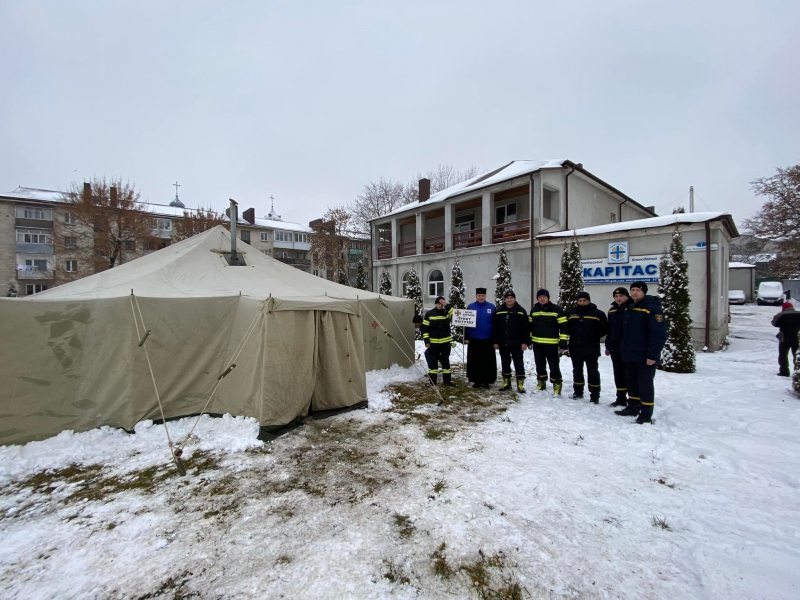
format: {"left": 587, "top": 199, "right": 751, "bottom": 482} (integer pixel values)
{"left": 53, "top": 177, "right": 155, "bottom": 280}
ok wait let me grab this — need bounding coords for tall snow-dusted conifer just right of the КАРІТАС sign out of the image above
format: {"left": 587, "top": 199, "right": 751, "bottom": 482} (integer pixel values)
{"left": 658, "top": 231, "right": 696, "bottom": 373}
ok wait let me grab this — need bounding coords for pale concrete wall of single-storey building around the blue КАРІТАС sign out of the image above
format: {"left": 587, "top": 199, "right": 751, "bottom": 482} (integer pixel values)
{"left": 536, "top": 222, "right": 730, "bottom": 351}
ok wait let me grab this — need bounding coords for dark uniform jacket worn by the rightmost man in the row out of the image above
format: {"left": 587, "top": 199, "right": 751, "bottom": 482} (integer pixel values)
{"left": 620, "top": 296, "right": 667, "bottom": 364}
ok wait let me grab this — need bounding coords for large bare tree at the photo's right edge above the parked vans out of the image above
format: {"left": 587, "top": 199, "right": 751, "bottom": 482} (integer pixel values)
{"left": 744, "top": 165, "right": 800, "bottom": 278}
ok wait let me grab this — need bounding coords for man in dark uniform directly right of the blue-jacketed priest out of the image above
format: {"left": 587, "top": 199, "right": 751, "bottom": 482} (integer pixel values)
{"left": 492, "top": 290, "right": 528, "bottom": 393}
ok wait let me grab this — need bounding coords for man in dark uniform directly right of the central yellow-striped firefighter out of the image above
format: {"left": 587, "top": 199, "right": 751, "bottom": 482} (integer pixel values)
{"left": 566, "top": 292, "right": 608, "bottom": 404}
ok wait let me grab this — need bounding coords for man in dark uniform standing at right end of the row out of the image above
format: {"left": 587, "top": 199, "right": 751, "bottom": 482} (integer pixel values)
{"left": 615, "top": 281, "right": 667, "bottom": 425}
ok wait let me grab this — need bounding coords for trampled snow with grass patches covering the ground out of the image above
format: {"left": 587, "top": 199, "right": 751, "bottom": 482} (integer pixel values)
{"left": 0, "top": 305, "right": 800, "bottom": 599}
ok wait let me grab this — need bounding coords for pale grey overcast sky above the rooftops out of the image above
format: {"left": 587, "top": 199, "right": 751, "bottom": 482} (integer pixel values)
{"left": 0, "top": 0, "right": 800, "bottom": 229}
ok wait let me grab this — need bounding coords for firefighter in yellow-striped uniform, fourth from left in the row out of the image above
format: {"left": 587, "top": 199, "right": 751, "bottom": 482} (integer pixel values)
{"left": 528, "top": 289, "right": 569, "bottom": 396}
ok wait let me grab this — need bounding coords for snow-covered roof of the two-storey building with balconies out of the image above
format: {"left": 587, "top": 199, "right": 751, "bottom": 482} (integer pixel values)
{"left": 370, "top": 159, "right": 655, "bottom": 221}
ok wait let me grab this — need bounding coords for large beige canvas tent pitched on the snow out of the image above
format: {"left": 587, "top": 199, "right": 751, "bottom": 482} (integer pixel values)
{"left": 0, "top": 226, "right": 414, "bottom": 444}
